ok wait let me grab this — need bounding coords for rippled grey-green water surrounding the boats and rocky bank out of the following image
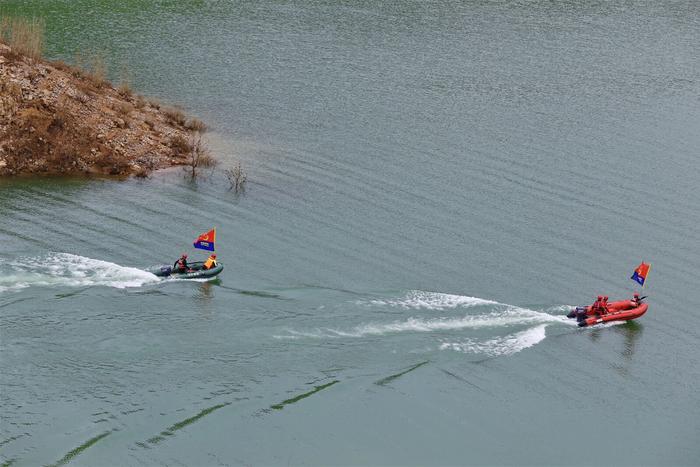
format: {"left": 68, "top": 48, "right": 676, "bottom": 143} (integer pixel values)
{"left": 0, "top": 0, "right": 700, "bottom": 465}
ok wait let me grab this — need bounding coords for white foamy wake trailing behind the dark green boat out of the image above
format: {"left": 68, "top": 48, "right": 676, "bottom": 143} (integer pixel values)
{"left": 0, "top": 253, "right": 159, "bottom": 293}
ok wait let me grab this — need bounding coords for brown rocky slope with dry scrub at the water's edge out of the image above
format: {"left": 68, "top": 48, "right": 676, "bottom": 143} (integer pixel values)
{"left": 0, "top": 42, "right": 204, "bottom": 176}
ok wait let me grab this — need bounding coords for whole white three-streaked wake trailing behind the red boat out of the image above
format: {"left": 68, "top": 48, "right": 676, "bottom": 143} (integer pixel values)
{"left": 274, "top": 291, "right": 576, "bottom": 357}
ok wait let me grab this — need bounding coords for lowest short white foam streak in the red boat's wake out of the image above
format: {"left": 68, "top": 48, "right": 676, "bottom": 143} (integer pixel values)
{"left": 440, "top": 324, "right": 547, "bottom": 357}
